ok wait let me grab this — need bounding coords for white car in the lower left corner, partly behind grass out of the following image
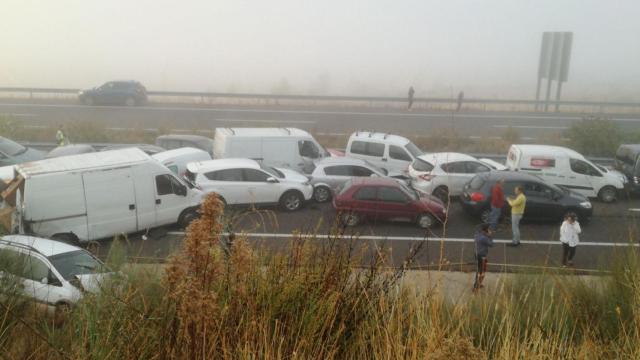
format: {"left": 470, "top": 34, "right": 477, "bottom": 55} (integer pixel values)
{"left": 0, "top": 235, "right": 111, "bottom": 313}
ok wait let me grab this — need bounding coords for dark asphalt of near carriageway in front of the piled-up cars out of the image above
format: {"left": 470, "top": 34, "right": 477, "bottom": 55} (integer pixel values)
{"left": 92, "top": 199, "right": 640, "bottom": 270}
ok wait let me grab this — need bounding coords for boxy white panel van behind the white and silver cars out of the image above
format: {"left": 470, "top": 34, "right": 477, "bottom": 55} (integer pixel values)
{"left": 213, "top": 128, "right": 331, "bottom": 174}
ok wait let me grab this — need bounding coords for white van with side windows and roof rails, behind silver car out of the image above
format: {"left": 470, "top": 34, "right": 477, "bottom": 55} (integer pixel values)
{"left": 345, "top": 131, "right": 423, "bottom": 172}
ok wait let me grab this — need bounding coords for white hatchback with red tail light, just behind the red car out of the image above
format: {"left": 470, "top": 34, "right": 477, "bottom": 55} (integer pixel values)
{"left": 409, "top": 152, "right": 492, "bottom": 201}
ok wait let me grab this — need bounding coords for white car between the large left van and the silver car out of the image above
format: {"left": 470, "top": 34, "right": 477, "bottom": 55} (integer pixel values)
{"left": 186, "top": 159, "right": 313, "bottom": 211}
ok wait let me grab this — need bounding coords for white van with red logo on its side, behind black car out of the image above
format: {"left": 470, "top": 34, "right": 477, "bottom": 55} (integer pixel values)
{"left": 506, "top": 145, "right": 626, "bottom": 202}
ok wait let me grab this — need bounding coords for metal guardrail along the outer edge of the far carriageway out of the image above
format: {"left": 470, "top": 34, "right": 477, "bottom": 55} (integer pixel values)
{"left": 0, "top": 87, "right": 640, "bottom": 108}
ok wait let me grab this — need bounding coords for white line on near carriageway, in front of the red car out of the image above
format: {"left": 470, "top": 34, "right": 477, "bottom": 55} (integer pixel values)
{"left": 167, "top": 231, "right": 640, "bottom": 247}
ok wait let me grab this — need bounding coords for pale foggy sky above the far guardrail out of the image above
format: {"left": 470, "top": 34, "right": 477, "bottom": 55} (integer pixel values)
{"left": 0, "top": 0, "right": 640, "bottom": 99}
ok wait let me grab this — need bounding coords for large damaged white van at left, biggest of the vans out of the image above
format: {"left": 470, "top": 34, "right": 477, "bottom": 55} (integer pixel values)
{"left": 3, "top": 148, "right": 203, "bottom": 242}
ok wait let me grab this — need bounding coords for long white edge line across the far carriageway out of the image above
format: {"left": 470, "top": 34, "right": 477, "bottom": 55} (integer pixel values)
{"left": 0, "top": 103, "right": 640, "bottom": 122}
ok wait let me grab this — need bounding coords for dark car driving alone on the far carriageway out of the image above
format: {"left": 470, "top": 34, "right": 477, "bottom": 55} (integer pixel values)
{"left": 78, "top": 81, "right": 147, "bottom": 106}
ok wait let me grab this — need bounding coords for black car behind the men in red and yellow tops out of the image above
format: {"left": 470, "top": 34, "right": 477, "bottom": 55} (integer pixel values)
{"left": 460, "top": 171, "right": 593, "bottom": 222}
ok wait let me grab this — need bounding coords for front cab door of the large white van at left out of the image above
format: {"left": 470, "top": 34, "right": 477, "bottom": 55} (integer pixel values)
{"left": 153, "top": 173, "right": 187, "bottom": 226}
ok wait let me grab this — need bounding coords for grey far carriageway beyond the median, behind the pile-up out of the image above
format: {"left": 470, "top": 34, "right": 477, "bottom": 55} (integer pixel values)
{"left": 0, "top": 99, "right": 640, "bottom": 140}
